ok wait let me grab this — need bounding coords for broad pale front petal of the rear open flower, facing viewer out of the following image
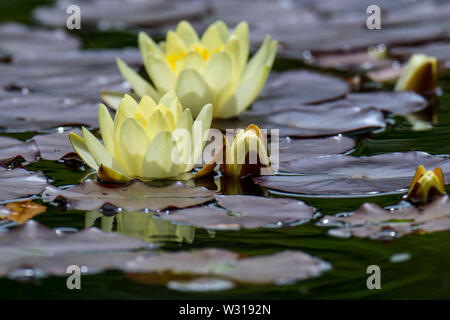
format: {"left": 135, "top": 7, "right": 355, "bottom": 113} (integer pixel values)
{"left": 176, "top": 69, "right": 213, "bottom": 116}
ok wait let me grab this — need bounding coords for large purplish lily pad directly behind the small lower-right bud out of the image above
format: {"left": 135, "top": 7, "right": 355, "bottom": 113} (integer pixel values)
{"left": 253, "top": 152, "right": 450, "bottom": 195}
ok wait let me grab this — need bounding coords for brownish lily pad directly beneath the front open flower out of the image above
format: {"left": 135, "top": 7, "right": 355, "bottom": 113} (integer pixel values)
{"left": 43, "top": 180, "right": 214, "bottom": 211}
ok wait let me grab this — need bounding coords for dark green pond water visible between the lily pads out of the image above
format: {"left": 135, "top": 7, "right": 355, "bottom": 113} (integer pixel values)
{"left": 0, "top": 1, "right": 450, "bottom": 299}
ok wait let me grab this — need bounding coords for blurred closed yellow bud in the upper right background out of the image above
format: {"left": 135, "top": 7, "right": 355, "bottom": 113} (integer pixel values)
{"left": 395, "top": 54, "right": 438, "bottom": 93}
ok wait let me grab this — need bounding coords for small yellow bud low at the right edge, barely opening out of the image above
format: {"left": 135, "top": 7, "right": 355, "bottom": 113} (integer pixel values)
{"left": 406, "top": 165, "right": 446, "bottom": 202}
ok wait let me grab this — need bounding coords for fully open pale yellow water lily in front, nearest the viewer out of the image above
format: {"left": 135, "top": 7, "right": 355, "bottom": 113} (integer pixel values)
{"left": 69, "top": 91, "right": 213, "bottom": 182}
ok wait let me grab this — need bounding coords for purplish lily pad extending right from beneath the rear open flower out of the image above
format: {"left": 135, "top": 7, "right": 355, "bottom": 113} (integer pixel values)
{"left": 212, "top": 99, "right": 386, "bottom": 137}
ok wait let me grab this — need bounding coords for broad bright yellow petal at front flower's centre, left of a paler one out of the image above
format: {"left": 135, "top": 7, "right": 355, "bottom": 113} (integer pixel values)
{"left": 119, "top": 118, "right": 149, "bottom": 177}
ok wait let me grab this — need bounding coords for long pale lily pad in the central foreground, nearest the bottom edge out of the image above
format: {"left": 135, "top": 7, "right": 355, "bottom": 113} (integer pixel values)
{"left": 126, "top": 249, "right": 331, "bottom": 284}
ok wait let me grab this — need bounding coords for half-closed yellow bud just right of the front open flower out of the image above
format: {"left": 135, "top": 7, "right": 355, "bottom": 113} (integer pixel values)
{"left": 196, "top": 124, "right": 273, "bottom": 177}
